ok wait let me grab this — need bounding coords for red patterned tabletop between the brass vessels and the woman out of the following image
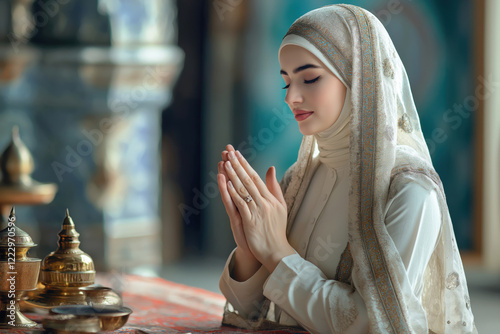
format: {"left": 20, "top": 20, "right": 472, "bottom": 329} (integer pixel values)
{"left": 0, "top": 274, "right": 305, "bottom": 334}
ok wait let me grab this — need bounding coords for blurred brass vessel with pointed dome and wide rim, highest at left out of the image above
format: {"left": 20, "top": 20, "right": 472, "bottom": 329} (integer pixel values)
{"left": 0, "top": 126, "right": 57, "bottom": 229}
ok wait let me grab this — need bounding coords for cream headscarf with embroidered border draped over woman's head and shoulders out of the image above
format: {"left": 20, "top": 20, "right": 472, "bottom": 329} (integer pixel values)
{"left": 225, "top": 4, "right": 477, "bottom": 334}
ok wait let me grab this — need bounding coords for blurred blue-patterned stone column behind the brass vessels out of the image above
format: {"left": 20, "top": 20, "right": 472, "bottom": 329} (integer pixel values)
{"left": 0, "top": 0, "right": 184, "bottom": 272}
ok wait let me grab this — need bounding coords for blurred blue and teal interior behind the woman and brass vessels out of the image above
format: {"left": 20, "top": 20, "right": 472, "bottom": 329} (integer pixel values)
{"left": 0, "top": 0, "right": 500, "bottom": 333}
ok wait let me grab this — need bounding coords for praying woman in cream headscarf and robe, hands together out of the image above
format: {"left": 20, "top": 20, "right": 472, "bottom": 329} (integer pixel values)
{"left": 218, "top": 5, "right": 476, "bottom": 333}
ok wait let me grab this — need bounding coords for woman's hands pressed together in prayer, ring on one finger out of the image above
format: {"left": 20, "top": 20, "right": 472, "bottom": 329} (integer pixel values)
{"left": 217, "top": 145, "right": 295, "bottom": 281}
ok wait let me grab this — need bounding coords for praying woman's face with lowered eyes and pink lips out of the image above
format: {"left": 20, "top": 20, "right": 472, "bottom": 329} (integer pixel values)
{"left": 279, "top": 45, "right": 347, "bottom": 135}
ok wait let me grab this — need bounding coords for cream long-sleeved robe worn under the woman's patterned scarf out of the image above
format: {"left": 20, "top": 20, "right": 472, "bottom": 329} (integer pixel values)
{"left": 220, "top": 163, "right": 441, "bottom": 333}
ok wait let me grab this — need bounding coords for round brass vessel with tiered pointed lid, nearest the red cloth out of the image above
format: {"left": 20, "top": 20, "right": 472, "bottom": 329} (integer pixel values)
{"left": 25, "top": 210, "right": 95, "bottom": 309}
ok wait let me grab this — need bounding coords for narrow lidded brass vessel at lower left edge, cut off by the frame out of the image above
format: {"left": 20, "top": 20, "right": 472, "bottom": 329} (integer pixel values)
{"left": 0, "top": 208, "right": 40, "bottom": 329}
